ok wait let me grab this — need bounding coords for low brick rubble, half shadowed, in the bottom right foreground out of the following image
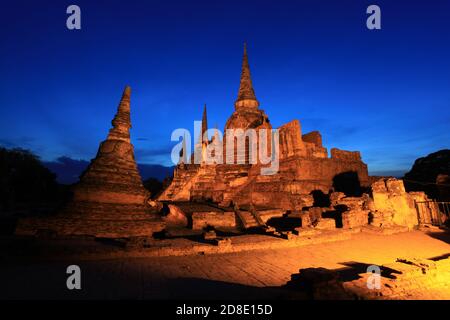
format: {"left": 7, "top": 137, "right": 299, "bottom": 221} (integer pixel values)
{"left": 286, "top": 258, "right": 450, "bottom": 300}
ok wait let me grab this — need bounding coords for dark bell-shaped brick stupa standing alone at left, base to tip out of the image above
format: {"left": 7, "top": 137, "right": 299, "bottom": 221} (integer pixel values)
{"left": 16, "top": 87, "right": 164, "bottom": 238}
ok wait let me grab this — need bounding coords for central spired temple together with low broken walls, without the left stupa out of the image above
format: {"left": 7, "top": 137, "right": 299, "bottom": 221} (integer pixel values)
{"left": 158, "top": 48, "right": 444, "bottom": 234}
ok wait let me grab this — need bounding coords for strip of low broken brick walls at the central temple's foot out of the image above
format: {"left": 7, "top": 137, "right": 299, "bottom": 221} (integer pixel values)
{"left": 164, "top": 178, "right": 436, "bottom": 240}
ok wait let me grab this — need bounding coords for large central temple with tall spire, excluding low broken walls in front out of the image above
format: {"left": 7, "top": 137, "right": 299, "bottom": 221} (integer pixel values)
{"left": 159, "top": 47, "right": 369, "bottom": 210}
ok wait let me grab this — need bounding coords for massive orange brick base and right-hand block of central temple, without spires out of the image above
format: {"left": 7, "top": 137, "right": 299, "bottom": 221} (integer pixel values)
{"left": 159, "top": 120, "right": 369, "bottom": 210}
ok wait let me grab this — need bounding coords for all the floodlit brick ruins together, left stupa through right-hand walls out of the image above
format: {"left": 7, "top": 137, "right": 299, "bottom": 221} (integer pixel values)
{"left": 16, "top": 49, "right": 445, "bottom": 239}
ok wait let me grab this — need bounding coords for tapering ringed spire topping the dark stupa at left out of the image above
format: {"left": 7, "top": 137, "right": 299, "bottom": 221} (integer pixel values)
{"left": 108, "top": 86, "right": 131, "bottom": 142}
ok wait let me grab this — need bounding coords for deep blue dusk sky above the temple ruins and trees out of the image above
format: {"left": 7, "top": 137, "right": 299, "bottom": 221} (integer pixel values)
{"left": 0, "top": 0, "right": 450, "bottom": 173}
